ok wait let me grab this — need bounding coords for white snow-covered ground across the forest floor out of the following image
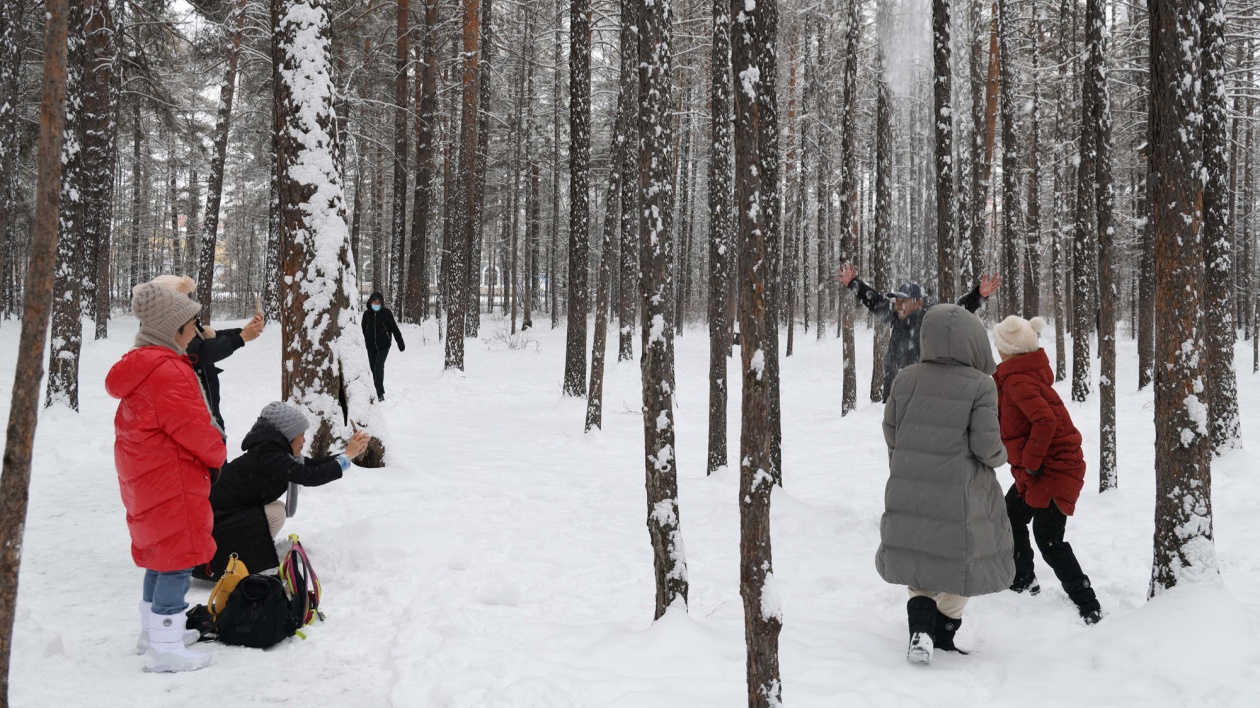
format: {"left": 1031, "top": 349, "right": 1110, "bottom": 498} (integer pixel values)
{"left": 0, "top": 311, "right": 1260, "bottom": 708}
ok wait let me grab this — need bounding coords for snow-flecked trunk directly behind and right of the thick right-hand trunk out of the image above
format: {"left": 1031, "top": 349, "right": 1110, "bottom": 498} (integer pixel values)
{"left": 1201, "top": 0, "right": 1241, "bottom": 454}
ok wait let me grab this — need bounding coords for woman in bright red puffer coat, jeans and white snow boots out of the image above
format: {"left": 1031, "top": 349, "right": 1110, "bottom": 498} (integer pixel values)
{"left": 105, "top": 282, "right": 227, "bottom": 671}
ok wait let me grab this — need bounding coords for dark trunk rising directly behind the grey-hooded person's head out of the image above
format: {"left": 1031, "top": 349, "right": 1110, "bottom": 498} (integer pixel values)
{"left": 932, "top": 0, "right": 955, "bottom": 302}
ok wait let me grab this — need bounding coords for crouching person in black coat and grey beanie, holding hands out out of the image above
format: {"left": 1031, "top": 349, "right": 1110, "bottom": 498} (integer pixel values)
{"left": 200, "top": 401, "right": 370, "bottom": 578}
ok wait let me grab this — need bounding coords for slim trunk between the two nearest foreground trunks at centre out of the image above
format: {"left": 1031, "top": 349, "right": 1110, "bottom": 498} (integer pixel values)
{"left": 705, "top": 0, "right": 735, "bottom": 474}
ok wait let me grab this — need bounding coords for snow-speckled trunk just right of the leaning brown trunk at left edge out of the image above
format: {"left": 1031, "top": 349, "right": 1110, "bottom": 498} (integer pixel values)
{"left": 44, "top": 0, "right": 87, "bottom": 411}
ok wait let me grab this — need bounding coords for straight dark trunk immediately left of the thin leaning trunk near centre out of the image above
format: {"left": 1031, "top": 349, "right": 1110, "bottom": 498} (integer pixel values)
{"left": 563, "top": 0, "right": 591, "bottom": 396}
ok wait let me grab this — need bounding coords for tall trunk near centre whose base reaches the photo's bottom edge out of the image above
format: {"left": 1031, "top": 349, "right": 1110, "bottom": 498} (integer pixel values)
{"left": 731, "top": 0, "right": 782, "bottom": 707}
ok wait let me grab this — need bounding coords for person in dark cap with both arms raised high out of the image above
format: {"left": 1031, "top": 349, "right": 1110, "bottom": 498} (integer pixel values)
{"left": 838, "top": 263, "right": 1002, "bottom": 401}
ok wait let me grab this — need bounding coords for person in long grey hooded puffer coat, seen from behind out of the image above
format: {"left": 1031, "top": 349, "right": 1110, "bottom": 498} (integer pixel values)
{"left": 874, "top": 305, "right": 1014, "bottom": 664}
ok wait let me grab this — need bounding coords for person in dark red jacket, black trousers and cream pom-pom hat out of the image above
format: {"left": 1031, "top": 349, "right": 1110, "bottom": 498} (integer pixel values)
{"left": 993, "top": 315, "right": 1103, "bottom": 625}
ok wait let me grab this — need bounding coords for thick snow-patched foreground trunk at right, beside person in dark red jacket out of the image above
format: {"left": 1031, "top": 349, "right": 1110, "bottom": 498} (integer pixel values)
{"left": 1149, "top": 0, "right": 1220, "bottom": 596}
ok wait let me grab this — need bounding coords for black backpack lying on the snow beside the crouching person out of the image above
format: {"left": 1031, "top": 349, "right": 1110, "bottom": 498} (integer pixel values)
{"left": 217, "top": 573, "right": 305, "bottom": 649}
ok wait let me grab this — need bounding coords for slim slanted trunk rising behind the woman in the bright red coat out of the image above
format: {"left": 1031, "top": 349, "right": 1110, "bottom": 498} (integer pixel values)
{"left": 197, "top": 0, "right": 245, "bottom": 326}
